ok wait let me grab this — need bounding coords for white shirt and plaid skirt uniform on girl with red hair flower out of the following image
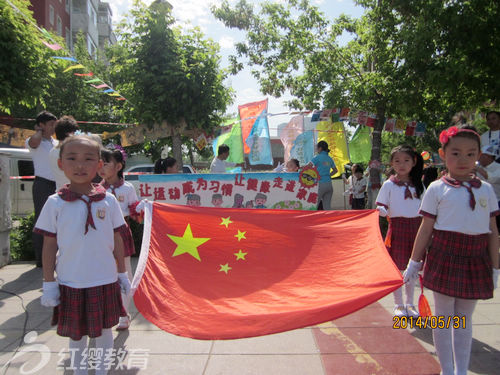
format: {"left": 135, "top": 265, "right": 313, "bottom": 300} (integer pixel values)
{"left": 420, "top": 177, "right": 499, "bottom": 299}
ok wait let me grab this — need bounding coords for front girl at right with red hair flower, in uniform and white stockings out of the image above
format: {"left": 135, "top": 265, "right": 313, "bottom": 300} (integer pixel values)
{"left": 403, "top": 125, "right": 499, "bottom": 375}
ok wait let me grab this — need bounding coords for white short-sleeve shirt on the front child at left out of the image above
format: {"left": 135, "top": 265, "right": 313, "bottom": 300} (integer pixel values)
{"left": 35, "top": 193, "right": 125, "bottom": 288}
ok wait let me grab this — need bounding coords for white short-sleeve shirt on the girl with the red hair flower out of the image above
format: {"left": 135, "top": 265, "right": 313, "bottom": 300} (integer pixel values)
{"left": 420, "top": 179, "right": 498, "bottom": 235}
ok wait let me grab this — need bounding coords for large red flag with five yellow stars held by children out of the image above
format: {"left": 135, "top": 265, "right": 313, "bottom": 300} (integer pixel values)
{"left": 133, "top": 203, "right": 402, "bottom": 340}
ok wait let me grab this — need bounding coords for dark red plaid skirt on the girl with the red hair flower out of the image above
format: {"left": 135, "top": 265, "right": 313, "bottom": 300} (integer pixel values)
{"left": 424, "top": 230, "right": 493, "bottom": 299}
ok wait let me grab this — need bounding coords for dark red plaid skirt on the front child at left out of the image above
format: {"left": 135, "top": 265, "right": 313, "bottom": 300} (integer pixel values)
{"left": 52, "top": 282, "right": 127, "bottom": 340}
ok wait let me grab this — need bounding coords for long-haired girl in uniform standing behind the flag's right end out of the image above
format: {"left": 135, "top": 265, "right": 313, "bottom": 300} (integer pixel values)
{"left": 376, "top": 145, "right": 424, "bottom": 318}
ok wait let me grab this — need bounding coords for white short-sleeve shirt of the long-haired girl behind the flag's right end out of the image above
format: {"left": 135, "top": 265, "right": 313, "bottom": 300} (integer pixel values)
{"left": 376, "top": 179, "right": 423, "bottom": 217}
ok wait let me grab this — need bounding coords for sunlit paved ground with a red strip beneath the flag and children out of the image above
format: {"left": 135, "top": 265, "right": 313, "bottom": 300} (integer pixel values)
{"left": 0, "top": 258, "right": 500, "bottom": 375}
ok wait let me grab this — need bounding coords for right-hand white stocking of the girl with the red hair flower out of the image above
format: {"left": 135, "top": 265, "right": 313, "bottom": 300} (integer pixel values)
{"left": 452, "top": 298, "right": 477, "bottom": 375}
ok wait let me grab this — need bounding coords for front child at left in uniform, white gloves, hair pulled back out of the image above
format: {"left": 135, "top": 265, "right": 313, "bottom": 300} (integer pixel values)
{"left": 34, "top": 136, "right": 130, "bottom": 374}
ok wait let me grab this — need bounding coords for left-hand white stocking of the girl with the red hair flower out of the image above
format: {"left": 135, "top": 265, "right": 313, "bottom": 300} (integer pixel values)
{"left": 432, "top": 292, "right": 455, "bottom": 375}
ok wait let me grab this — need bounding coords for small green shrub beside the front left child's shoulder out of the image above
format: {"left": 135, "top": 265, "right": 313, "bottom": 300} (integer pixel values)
{"left": 10, "top": 213, "right": 35, "bottom": 261}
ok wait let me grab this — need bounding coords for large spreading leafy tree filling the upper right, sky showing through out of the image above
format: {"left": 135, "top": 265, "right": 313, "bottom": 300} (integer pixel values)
{"left": 212, "top": 0, "right": 500, "bottom": 182}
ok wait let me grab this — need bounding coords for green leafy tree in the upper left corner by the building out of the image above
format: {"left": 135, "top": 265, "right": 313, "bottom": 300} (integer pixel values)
{"left": 0, "top": 0, "right": 52, "bottom": 113}
